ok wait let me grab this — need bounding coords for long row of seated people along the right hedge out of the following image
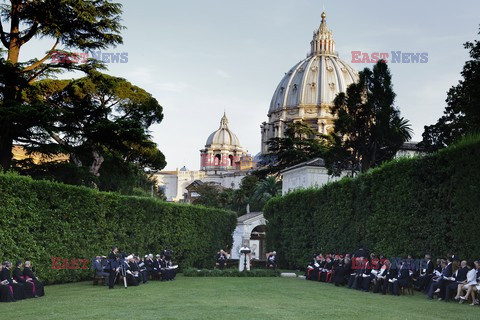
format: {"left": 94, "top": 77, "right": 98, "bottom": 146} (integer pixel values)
{"left": 305, "top": 254, "right": 480, "bottom": 304}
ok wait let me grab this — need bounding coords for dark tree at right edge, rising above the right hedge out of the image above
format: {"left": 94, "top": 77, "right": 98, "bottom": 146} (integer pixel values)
{"left": 421, "top": 26, "right": 480, "bottom": 151}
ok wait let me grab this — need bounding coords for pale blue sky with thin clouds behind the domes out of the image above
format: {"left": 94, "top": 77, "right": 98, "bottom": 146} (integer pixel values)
{"left": 16, "top": 0, "right": 480, "bottom": 170}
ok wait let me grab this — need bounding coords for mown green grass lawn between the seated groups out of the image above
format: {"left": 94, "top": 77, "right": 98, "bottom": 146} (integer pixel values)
{"left": 0, "top": 276, "right": 480, "bottom": 320}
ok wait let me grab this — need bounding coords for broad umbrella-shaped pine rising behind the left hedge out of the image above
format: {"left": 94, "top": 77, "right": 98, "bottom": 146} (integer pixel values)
{"left": 17, "top": 71, "right": 166, "bottom": 182}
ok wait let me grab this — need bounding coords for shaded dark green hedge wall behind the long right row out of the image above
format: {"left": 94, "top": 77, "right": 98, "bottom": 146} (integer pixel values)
{"left": 264, "top": 137, "right": 480, "bottom": 267}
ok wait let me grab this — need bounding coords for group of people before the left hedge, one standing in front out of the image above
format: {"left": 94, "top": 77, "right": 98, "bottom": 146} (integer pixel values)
{"left": 92, "top": 254, "right": 176, "bottom": 286}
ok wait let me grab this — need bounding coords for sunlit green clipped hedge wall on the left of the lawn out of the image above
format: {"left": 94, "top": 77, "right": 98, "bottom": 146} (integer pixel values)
{"left": 0, "top": 174, "right": 236, "bottom": 283}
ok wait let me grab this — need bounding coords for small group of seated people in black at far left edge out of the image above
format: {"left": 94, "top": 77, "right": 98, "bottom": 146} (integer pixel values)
{"left": 0, "top": 260, "right": 45, "bottom": 302}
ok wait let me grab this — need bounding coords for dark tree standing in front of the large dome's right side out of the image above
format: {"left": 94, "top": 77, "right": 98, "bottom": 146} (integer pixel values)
{"left": 326, "top": 60, "right": 412, "bottom": 175}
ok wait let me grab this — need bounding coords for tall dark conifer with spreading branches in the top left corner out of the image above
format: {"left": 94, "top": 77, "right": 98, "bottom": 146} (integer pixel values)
{"left": 0, "top": 0, "right": 123, "bottom": 170}
